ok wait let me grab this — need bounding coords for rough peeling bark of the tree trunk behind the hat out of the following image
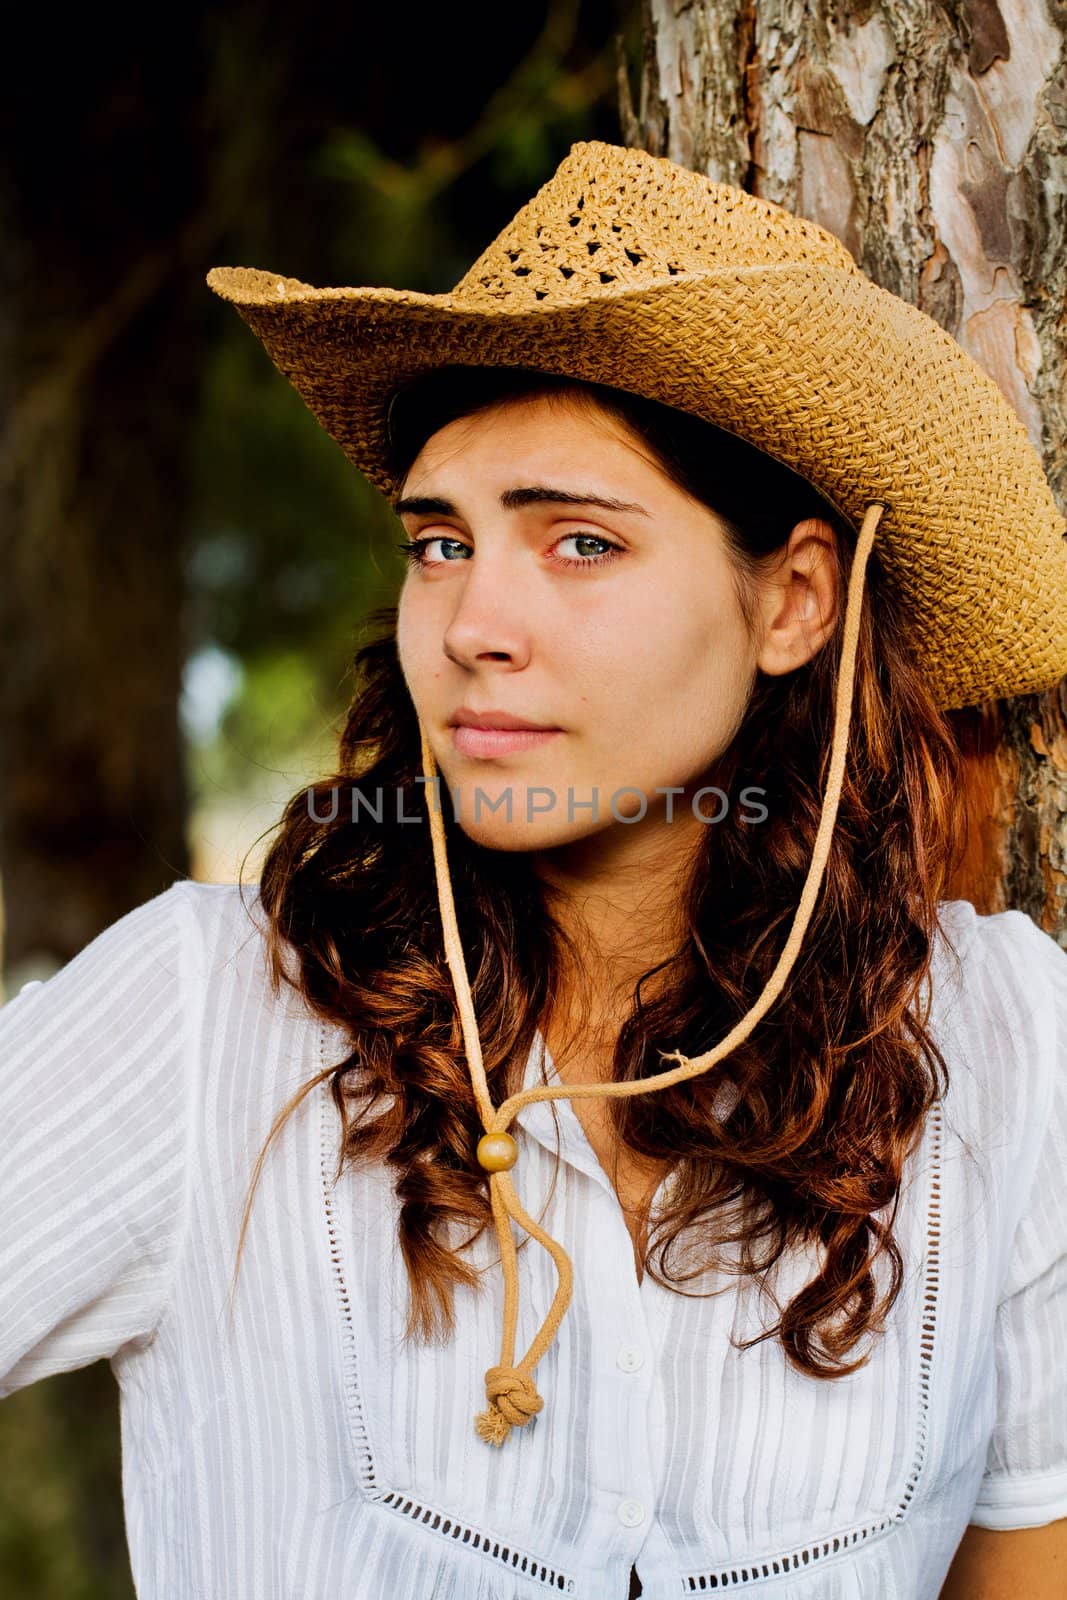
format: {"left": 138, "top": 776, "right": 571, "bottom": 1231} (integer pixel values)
{"left": 619, "top": 0, "right": 1067, "bottom": 944}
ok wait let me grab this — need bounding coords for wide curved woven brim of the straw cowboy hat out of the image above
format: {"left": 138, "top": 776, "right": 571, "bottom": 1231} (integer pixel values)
{"left": 208, "top": 262, "right": 1067, "bottom": 709}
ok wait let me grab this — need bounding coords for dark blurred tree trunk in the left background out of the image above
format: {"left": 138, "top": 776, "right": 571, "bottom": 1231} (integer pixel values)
{"left": 0, "top": 31, "right": 212, "bottom": 990}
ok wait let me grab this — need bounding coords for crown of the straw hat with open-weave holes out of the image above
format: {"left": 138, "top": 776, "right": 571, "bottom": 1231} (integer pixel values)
{"left": 451, "top": 139, "right": 857, "bottom": 310}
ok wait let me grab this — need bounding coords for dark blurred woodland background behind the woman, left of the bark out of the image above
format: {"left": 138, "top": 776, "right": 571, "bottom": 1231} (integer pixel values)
{"left": 0, "top": 0, "right": 640, "bottom": 1600}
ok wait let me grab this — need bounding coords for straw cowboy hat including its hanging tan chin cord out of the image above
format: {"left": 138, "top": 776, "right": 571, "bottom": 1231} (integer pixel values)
{"left": 208, "top": 141, "right": 1067, "bottom": 1445}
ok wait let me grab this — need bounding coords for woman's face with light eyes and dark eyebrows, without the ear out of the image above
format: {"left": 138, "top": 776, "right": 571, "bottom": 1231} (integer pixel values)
{"left": 397, "top": 397, "right": 825, "bottom": 850}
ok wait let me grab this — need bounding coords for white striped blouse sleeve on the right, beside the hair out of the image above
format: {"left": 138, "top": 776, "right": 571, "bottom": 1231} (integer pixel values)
{"left": 971, "top": 912, "right": 1067, "bottom": 1530}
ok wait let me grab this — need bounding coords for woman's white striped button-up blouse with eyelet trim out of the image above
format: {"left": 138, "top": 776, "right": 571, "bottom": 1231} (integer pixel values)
{"left": 0, "top": 882, "right": 1067, "bottom": 1600}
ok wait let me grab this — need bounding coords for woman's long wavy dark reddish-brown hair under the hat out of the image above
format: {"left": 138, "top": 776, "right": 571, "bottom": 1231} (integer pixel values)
{"left": 234, "top": 368, "right": 965, "bottom": 1378}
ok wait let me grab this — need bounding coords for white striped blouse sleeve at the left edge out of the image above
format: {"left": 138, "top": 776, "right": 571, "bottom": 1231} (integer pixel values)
{"left": 0, "top": 882, "right": 195, "bottom": 1397}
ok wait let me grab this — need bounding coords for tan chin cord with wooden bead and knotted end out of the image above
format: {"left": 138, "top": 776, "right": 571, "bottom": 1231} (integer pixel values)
{"left": 419, "top": 501, "right": 886, "bottom": 1446}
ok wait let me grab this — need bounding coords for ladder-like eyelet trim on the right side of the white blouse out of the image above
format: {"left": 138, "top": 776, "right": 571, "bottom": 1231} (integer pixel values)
{"left": 681, "top": 1102, "right": 941, "bottom": 1594}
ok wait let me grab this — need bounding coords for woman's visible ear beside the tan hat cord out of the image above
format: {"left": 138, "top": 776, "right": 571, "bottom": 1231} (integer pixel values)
{"left": 757, "top": 517, "right": 837, "bottom": 675}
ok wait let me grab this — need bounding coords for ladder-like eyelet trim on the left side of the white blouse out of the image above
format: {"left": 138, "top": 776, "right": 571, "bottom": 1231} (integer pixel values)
{"left": 318, "top": 1024, "right": 577, "bottom": 1595}
